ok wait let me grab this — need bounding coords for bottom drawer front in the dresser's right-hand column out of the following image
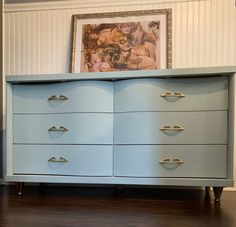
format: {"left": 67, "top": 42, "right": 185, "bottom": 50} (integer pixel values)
{"left": 114, "top": 145, "right": 227, "bottom": 178}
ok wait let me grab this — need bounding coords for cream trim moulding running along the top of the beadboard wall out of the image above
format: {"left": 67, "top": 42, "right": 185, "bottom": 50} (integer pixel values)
{"left": 3, "top": 0, "right": 208, "bottom": 12}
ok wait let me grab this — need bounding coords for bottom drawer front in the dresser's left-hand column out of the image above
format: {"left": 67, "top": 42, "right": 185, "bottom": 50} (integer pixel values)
{"left": 13, "top": 145, "right": 113, "bottom": 176}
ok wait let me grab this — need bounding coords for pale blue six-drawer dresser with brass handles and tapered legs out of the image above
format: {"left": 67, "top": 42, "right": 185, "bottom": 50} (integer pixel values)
{"left": 5, "top": 67, "right": 236, "bottom": 201}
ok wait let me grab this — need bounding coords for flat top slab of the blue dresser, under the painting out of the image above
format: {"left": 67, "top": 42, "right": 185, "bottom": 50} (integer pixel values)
{"left": 6, "top": 66, "right": 236, "bottom": 83}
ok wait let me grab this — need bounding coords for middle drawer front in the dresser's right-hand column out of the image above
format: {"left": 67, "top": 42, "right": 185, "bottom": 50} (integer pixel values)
{"left": 114, "top": 111, "right": 227, "bottom": 144}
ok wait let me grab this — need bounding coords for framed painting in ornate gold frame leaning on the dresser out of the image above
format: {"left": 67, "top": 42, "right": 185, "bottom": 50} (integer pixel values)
{"left": 70, "top": 9, "right": 172, "bottom": 73}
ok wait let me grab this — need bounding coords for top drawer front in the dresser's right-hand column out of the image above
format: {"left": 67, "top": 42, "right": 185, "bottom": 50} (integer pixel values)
{"left": 115, "top": 77, "right": 228, "bottom": 112}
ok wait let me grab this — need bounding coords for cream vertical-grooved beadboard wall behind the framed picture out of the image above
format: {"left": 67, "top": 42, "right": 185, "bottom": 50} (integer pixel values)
{"left": 1, "top": 0, "right": 236, "bottom": 186}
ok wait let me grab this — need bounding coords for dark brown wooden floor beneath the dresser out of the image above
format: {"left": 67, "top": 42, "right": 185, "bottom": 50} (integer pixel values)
{"left": 0, "top": 185, "right": 236, "bottom": 227}
